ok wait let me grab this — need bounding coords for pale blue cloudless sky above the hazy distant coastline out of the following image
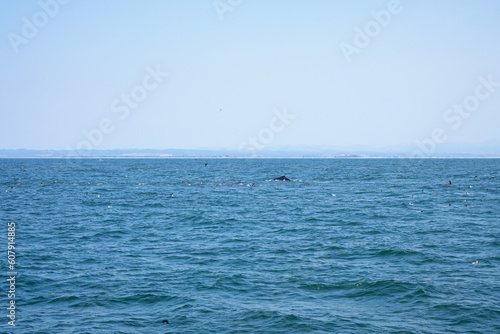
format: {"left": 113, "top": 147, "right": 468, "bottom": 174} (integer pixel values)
{"left": 0, "top": 0, "right": 500, "bottom": 149}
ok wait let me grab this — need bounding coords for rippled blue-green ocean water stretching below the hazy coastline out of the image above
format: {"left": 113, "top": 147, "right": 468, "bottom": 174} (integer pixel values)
{"left": 0, "top": 158, "right": 500, "bottom": 333}
